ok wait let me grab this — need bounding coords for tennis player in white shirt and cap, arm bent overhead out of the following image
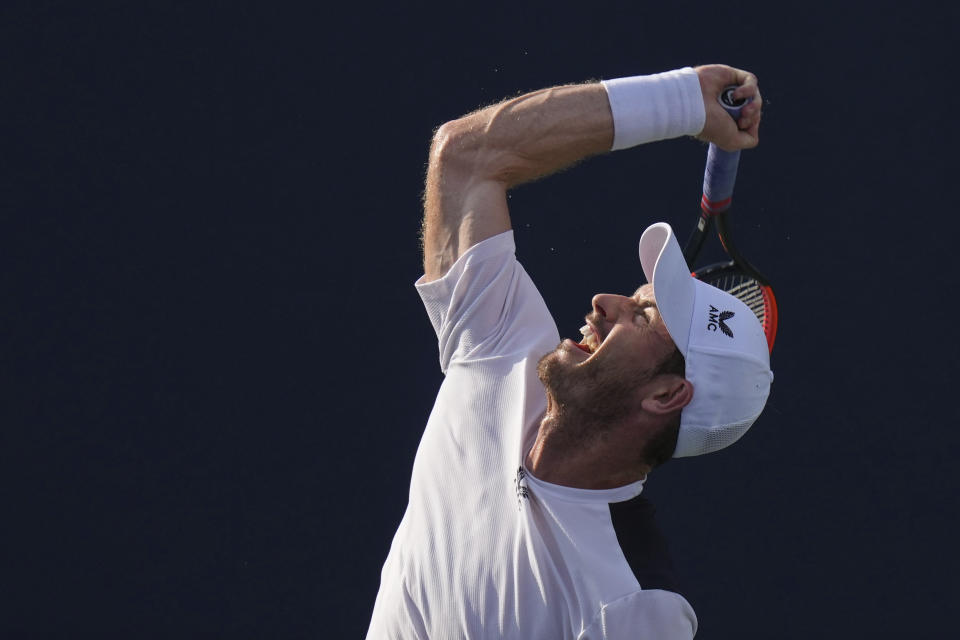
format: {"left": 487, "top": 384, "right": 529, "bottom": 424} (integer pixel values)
{"left": 367, "top": 65, "right": 773, "bottom": 640}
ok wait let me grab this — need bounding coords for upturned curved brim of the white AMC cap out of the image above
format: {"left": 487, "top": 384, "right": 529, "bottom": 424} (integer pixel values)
{"left": 640, "top": 222, "right": 697, "bottom": 357}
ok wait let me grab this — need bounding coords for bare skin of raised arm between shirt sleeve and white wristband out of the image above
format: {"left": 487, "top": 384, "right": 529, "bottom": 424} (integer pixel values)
{"left": 423, "top": 84, "right": 613, "bottom": 280}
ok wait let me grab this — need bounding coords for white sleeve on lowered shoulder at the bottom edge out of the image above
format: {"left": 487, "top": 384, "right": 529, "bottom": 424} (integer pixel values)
{"left": 579, "top": 589, "right": 697, "bottom": 640}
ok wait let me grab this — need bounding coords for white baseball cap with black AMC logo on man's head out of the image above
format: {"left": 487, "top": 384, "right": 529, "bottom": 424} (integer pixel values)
{"left": 640, "top": 222, "right": 773, "bottom": 458}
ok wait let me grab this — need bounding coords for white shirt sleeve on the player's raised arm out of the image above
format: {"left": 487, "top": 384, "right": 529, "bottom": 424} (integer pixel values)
{"left": 415, "top": 231, "right": 560, "bottom": 372}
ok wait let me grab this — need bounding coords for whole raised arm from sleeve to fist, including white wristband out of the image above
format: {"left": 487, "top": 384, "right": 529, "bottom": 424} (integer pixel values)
{"left": 423, "top": 65, "right": 760, "bottom": 281}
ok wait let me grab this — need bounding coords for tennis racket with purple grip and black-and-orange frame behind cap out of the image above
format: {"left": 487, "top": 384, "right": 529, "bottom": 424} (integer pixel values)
{"left": 683, "top": 86, "right": 777, "bottom": 352}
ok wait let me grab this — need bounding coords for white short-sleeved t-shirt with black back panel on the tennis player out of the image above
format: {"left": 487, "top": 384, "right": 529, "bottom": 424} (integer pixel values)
{"left": 367, "top": 231, "right": 697, "bottom": 640}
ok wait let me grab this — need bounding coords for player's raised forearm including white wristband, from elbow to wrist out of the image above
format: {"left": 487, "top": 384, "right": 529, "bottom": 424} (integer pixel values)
{"left": 428, "top": 68, "right": 704, "bottom": 194}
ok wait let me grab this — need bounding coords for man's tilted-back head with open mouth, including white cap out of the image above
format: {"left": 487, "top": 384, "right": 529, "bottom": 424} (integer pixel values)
{"left": 538, "top": 223, "right": 773, "bottom": 466}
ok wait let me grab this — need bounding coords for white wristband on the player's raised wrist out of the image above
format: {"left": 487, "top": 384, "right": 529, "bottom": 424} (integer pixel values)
{"left": 601, "top": 67, "right": 706, "bottom": 151}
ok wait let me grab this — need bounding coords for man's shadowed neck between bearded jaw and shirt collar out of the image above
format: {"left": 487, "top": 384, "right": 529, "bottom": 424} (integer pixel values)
{"left": 526, "top": 396, "right": 651, "bottom": 489}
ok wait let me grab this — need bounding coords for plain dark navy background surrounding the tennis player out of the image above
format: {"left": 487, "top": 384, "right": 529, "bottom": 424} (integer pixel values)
{"left": 0, "top": 1, "right": 960, "bottom": 638}
